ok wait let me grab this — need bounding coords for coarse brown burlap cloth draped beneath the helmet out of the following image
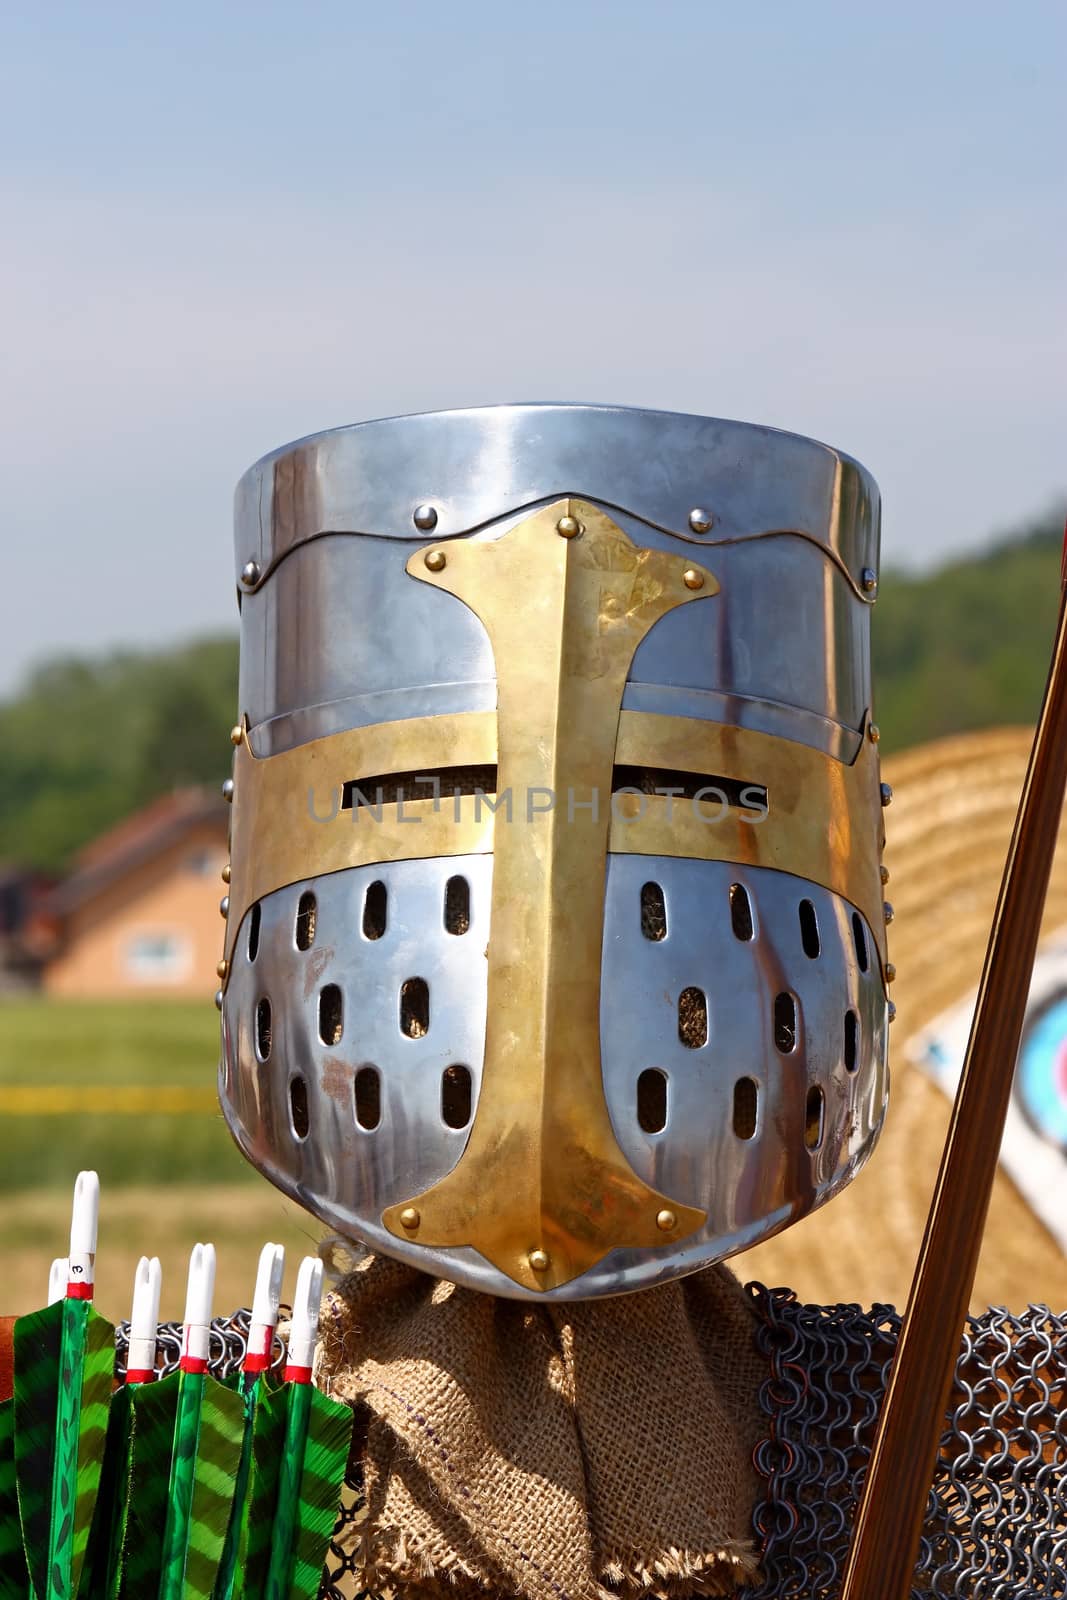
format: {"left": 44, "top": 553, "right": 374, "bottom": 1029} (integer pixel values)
{"left": 318, "top": 1256, "right": 766, "bottom": 1600}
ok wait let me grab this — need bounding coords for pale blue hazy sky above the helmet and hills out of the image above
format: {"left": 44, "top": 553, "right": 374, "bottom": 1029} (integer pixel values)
{"left": 0, "top": 0, "right": 1067, "bottom": 693}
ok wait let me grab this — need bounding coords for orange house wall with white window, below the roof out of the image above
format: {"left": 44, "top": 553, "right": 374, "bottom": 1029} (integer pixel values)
{"left": 43, "top": 822, "right": 227, "bottom": 998}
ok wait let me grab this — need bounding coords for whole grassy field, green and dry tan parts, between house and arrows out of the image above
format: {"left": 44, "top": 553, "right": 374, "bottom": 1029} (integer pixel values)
{"left": 0, "top": 997, "right": 322, "bottom": 1318}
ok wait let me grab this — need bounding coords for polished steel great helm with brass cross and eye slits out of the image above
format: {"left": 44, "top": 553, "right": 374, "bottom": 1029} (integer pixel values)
{"left": 218, "top": 405, "right": 889, "bottom": 1301}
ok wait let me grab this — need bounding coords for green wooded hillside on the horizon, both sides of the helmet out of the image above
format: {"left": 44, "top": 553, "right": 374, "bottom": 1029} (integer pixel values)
{"left": 0, "top": 517, "right": 1062, "bottom": 869}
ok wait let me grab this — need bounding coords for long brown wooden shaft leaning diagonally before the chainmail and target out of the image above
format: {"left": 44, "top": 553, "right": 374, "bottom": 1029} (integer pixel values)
{"left": 841, "top": 547, "right": 1067, "bottom": 1600}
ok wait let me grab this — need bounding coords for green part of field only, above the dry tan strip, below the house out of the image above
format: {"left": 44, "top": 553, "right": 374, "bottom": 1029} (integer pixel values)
{"left": 0, "top": 997, "right": 254, "bottom": 1194}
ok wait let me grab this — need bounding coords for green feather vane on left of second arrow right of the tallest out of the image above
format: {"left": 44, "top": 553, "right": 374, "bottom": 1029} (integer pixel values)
{"left": 117, "top": 1373, "right": 178, "bottom": 1600}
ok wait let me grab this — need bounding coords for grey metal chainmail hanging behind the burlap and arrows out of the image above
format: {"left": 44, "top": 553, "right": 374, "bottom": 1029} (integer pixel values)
{"left": 118, "top": 1283, "right": 1067, "bottom": 1600}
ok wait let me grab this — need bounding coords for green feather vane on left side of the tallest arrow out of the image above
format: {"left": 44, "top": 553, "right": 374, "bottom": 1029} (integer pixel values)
{"left": 11, "top": 1301, "right": 66, "bottom": 1600}
